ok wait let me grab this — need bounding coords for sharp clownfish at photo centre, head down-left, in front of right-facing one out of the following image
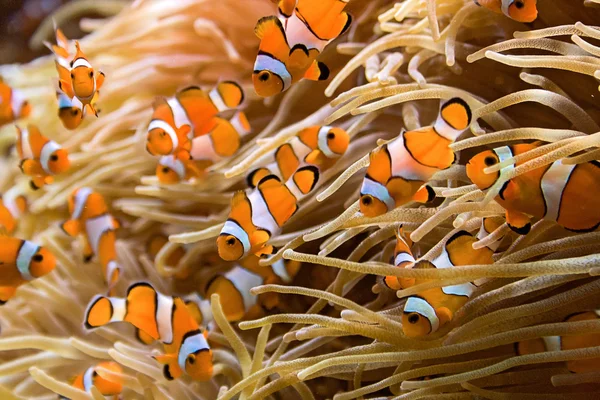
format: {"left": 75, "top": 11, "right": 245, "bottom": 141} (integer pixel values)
{"left": 217, "top": 173, "right": 302, "bottom": 261}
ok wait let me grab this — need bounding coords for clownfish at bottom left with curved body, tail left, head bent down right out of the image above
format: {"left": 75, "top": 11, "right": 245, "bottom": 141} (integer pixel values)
{"left": 84, "top": 282, "right": 213, "bottom": 381}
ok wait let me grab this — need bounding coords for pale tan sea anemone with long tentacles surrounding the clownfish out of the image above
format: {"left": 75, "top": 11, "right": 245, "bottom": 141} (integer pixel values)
{"left": 0, "top": 0, "right": 600, "bottom": 400}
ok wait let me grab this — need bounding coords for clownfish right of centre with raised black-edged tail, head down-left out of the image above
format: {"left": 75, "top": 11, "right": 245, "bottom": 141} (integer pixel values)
{"left": 360, "top": 98, "right": 471, "bottom": 217}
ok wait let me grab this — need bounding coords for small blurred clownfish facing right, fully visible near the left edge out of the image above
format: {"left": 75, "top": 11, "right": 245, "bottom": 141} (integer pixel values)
{"left": 16, "top": 125, "right": 71, "bottom": 190}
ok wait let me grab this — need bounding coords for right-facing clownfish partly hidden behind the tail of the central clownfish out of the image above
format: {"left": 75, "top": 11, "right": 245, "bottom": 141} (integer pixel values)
{"left": 246, "top": 126, "right": 350, "bottom": 188}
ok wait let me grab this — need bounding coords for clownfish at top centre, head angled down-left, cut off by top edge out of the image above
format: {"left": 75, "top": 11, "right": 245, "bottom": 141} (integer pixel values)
{"left": 252, "top": 0, "right": 352, "bottom": 97}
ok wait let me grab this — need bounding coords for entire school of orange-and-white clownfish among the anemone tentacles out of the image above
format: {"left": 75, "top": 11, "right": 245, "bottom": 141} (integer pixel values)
{"left": 0, "top": 0, "right": 600, "bottom": 398}
